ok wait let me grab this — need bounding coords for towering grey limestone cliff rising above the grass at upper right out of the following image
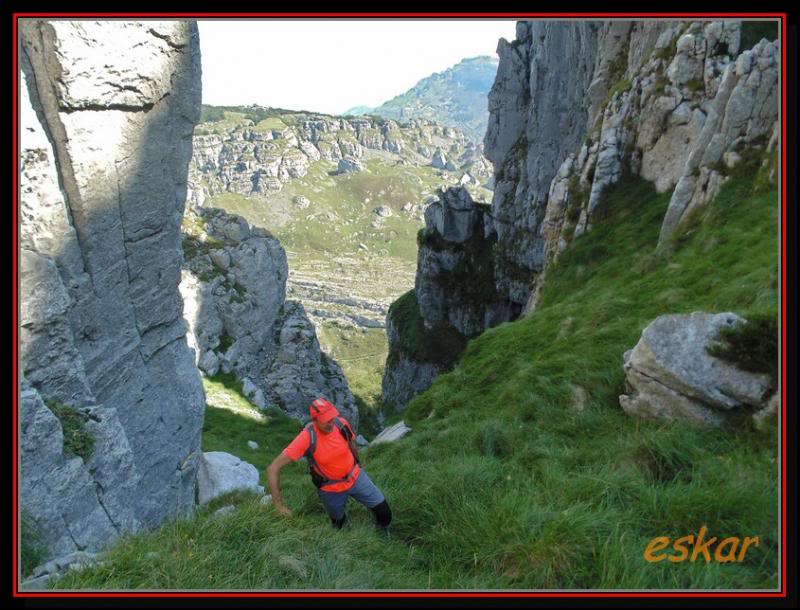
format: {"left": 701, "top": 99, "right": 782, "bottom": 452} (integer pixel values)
{"left": 384, "top": 21, "right": 780, "bottom": 408}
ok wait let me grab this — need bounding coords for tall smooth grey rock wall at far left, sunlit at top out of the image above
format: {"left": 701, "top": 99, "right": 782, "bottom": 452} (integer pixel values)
{"left": 19, "top": 20, "right": 204, "bottom": 557}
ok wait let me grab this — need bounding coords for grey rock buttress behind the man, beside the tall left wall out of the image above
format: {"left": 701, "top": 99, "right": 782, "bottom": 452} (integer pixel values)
{"left": 180, "top": 207, "right": 358, "bottom": 426}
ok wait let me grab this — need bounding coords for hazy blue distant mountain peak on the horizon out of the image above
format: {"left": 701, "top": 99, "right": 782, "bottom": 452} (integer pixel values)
{"left": 345, "top": 56, "right": 497, "bottom": 142}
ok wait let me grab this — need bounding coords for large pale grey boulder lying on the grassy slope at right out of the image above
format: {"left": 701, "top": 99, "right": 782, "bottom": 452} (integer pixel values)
{"left": 619, "top": 312, "right": 771, "bottom": 426}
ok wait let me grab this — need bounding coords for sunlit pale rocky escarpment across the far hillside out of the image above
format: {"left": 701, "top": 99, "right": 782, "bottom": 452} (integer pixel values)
{"left": 189, "top": 112, "right": 491, "bottom": 205}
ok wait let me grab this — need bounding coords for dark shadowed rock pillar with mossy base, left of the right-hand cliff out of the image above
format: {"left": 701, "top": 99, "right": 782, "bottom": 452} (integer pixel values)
{"left": 382, "top": 187, "right": 510, "bottom": 409}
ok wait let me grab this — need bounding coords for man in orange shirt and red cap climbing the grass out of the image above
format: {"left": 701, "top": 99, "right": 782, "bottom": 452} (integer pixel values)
{"left": 267, "top": 398, "right": 392, "bottom": 533}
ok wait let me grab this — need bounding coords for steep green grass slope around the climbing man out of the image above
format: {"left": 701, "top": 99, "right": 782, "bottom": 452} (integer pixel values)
{"left": 48, "top": 169, "right": 779, "bottom": 589}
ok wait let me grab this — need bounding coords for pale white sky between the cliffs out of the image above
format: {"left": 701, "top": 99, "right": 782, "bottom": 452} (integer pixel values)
{"left": 198, "top": 19, "right": 516, "bottom": 114}
